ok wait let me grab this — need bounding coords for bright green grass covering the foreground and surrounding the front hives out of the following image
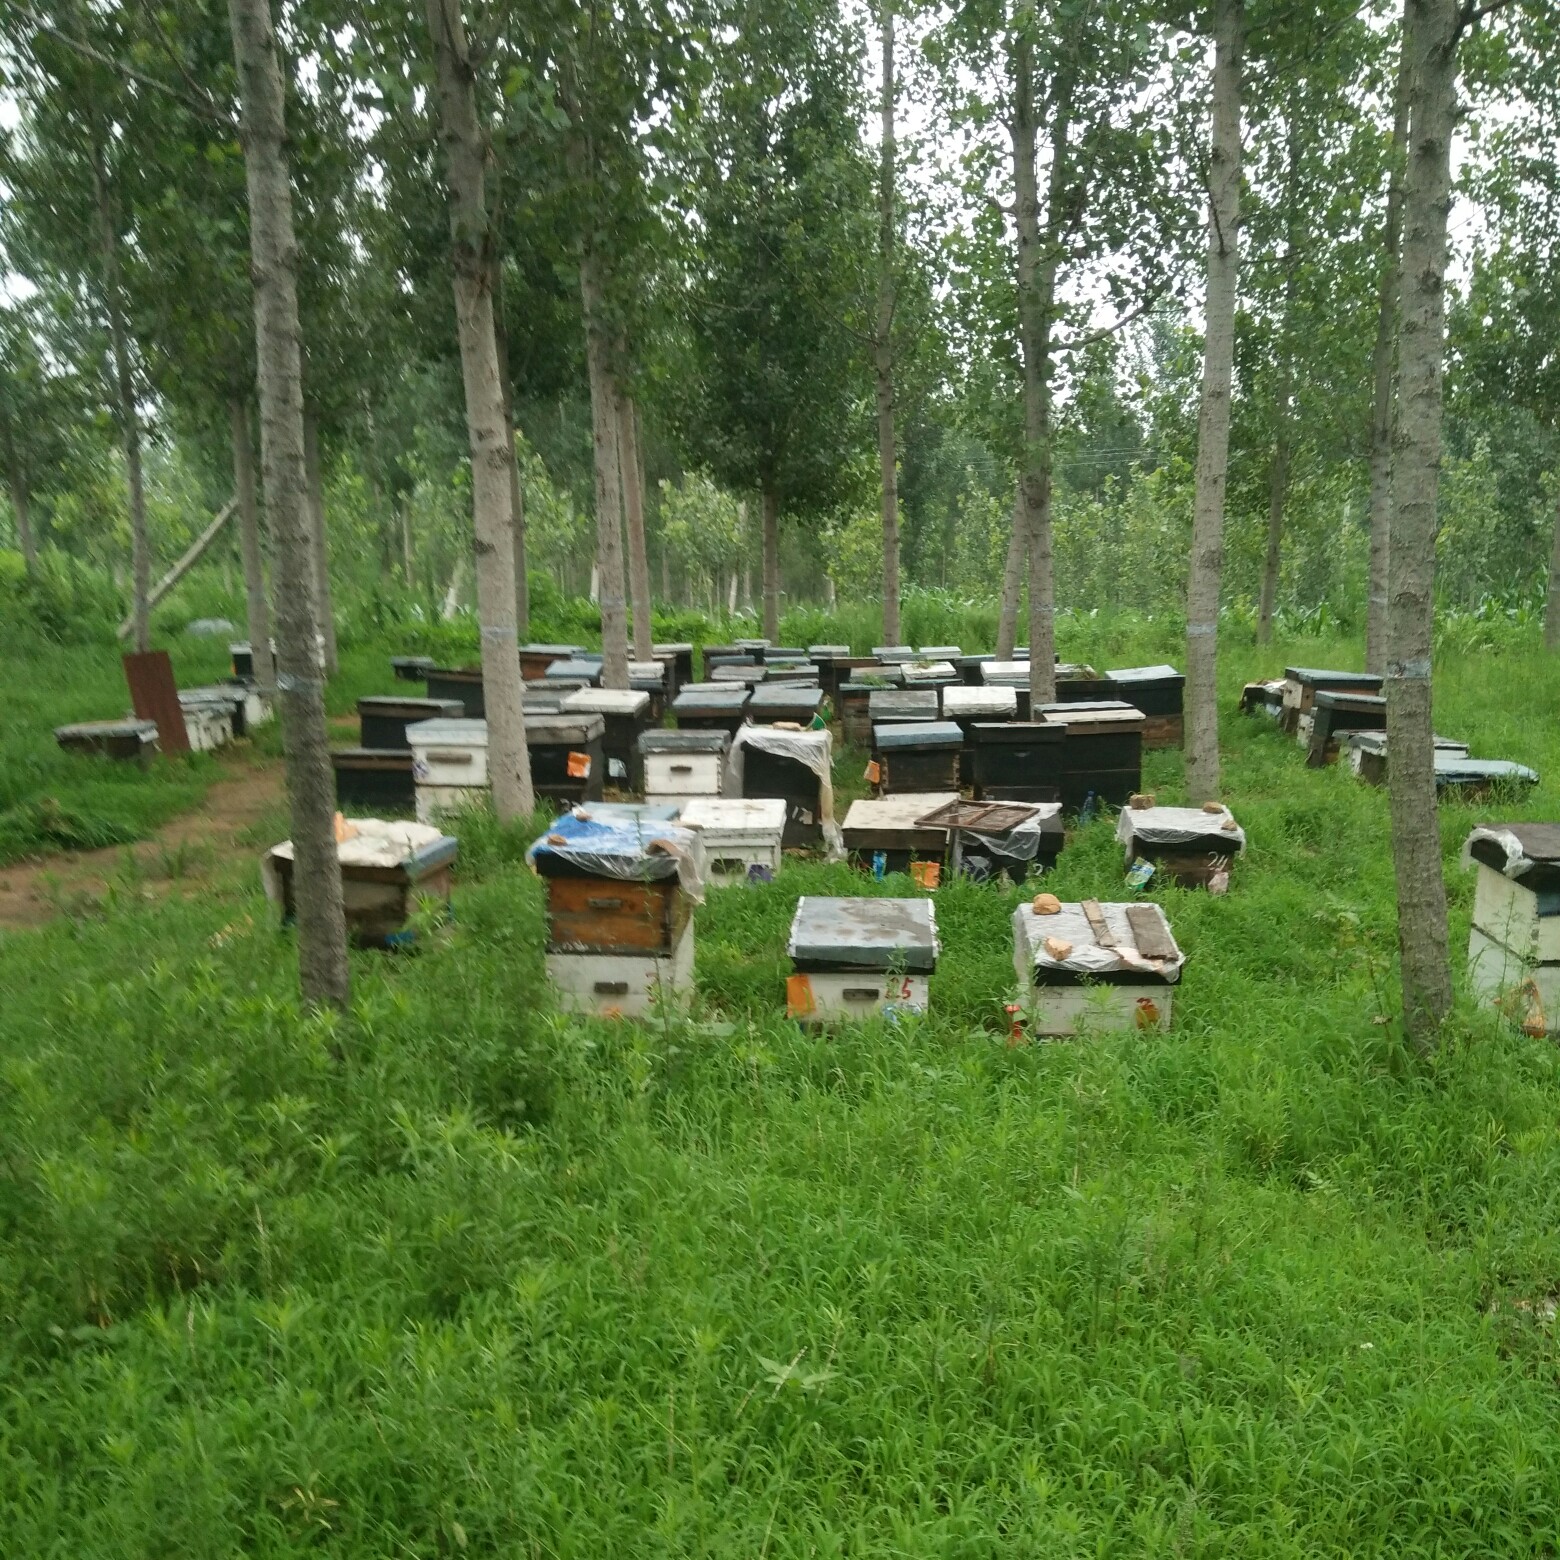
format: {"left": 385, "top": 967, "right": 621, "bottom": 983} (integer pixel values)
{"left": 0, "top": 620, "right": 1560, "bottom": 1560}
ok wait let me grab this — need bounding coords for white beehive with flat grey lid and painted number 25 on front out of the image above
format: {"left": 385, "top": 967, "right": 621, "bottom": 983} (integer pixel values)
{"left": 786, "top": 894, "right": 939, "bottom": 1023}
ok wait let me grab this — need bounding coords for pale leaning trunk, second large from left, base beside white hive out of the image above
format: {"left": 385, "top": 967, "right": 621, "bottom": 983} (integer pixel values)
{"left": 427, "top": 0, "right": 535, "bottom": 821}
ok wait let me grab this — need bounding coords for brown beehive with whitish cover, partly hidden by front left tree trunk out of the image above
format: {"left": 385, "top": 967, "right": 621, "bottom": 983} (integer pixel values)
{"left": 261, "top": 817, "right": 459, "bottom": 948}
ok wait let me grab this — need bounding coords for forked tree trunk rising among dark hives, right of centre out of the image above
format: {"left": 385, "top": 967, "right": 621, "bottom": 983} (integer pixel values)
{"left": 1012, "top": 30, "right": 1072, "bottom": 708}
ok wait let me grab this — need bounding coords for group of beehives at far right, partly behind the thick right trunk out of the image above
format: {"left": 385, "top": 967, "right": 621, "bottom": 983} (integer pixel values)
{"left": 1240, "top": 666, "right": 1538, "bottom": 800}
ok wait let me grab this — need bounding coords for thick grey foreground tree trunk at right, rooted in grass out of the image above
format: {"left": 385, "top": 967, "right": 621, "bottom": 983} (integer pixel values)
{"left": 1384, "top": 0, "right": 1459, "bottom": 1050}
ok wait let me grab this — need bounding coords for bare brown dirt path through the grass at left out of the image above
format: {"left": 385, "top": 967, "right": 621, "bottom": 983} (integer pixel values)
{"left": 0, "top": 752, "right": 284, "bottom": 931}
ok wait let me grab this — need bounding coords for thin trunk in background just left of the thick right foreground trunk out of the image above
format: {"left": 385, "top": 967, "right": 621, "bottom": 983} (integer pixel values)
{"left": 1365, "top": 31, "right": 1409, "bottom": 672}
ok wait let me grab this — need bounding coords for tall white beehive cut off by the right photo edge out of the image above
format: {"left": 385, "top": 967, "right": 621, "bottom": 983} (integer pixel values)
{"left": 1463, "top": 824, "right": 1560, "bottom": 1034}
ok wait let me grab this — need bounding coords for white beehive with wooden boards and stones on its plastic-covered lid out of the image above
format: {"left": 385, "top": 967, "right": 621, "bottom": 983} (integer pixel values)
{"left": 1012, "top": 900, "right": 1186, "bottom": 1037}
